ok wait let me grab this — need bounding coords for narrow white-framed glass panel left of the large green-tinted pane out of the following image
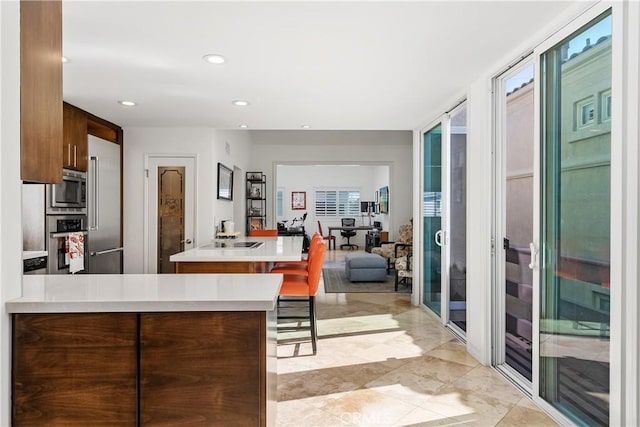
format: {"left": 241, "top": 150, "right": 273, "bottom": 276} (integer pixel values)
{"left": 494, "top": 60, "right": 535, "bottom": 389}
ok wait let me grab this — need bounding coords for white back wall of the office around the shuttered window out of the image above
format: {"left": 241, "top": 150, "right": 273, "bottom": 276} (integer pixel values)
{"left": 276, "top": 165, "right": 389, "bottom": 249}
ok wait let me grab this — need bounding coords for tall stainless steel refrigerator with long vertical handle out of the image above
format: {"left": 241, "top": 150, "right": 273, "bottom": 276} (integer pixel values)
{"left": 86, "top": 135, "right": 123, "bottom": 274}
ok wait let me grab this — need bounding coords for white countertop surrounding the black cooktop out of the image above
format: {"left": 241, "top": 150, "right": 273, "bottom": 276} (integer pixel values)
{"left": 169, "top": 236, "right": 302, "bottom": 262}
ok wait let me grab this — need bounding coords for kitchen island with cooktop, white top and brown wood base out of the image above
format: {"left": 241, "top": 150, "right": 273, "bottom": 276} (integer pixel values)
{"left": 170, "top": 236, "right": 302, "bottom": 273}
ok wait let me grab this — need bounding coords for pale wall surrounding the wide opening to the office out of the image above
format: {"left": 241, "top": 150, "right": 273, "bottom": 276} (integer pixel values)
{"left": 251, "top": 131, "right": 413, "bottom": 238}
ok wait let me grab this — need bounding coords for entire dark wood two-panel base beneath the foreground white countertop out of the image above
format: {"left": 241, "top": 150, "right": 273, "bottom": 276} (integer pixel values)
{"left": 12, "top": 311, "right": 276, "bottom": 426}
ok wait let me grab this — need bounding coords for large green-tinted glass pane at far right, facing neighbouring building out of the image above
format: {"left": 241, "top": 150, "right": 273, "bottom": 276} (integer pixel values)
{"left": 539, "top": 14, "right": 617, "bottom": 425}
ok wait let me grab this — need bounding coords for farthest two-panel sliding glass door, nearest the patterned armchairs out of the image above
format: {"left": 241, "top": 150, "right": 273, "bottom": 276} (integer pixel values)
{"left": 422, "top": 103, "right": 467, "bottom": 335}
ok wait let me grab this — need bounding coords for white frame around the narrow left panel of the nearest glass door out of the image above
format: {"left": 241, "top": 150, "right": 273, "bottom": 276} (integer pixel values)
{"left": 491, "top": 54, "right": 540, "bottom": 397}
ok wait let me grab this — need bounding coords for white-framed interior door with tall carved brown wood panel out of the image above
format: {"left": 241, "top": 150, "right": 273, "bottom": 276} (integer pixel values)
{"left": 144, "top": 156, "right": 196, "bottom": 273}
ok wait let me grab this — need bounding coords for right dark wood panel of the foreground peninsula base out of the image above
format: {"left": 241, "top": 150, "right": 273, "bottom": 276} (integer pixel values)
{"left": 140, "top": 312, "right": 266, "bottom": 426}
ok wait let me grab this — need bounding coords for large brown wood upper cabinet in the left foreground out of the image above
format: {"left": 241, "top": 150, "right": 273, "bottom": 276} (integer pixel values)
{"left": 20, "top": 1, "right": 63, "bottom": 183}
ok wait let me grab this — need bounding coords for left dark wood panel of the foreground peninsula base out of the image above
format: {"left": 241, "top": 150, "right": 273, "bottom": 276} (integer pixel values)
{"left": 13, "top": 313, "right": 137, "bottom": 426}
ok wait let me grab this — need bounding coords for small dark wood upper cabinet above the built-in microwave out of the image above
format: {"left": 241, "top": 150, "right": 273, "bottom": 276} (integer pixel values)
{"left": 62, "top": 102, "right": 88, "bottom": 172}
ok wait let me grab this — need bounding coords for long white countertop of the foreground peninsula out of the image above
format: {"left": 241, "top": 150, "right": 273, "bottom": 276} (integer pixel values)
{"left": 6, "top": 274, "right": 282, "bottom": 313}
